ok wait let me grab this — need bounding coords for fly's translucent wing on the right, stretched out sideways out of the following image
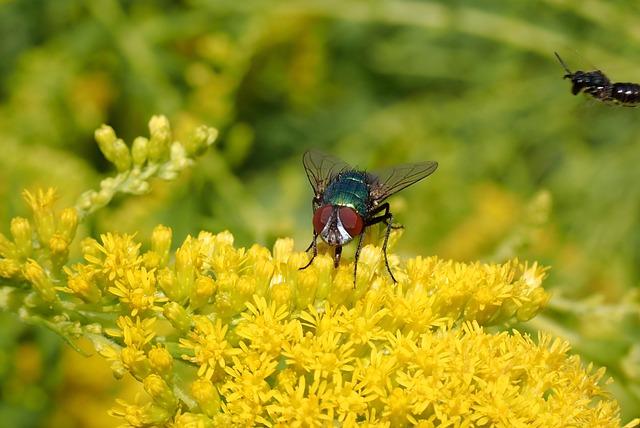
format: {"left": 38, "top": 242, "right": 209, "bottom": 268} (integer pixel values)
{"left": 366, "top": 161, "right": 438, "bottom": 205}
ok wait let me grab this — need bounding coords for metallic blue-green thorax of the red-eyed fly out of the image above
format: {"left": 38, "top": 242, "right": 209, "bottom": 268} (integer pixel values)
{"left": 322, "top": 171, "right": 369, "bottom": 218}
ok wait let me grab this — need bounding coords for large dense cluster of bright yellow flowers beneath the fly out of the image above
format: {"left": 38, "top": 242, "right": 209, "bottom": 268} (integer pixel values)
{"left": 17, "top": 221, "right": 619, "bottom": 427}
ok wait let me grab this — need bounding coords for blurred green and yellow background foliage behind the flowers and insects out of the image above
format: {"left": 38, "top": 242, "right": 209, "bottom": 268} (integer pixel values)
{"left": 0, "top": 0, "right": 640, "bottom": 427}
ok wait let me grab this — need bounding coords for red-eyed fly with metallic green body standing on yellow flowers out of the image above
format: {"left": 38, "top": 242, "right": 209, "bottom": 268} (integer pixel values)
{"left": 300, "top": 150, "right": 438, "bottom": 282}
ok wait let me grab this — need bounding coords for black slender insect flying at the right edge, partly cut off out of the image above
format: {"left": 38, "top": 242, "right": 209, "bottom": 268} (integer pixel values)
{"left": 554, "top": 52, "right": 640, "bottom": 107}
